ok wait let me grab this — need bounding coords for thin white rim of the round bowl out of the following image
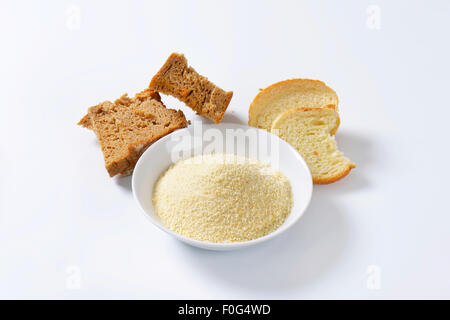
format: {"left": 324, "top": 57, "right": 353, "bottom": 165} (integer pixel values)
{"left": 131, "top": 122, "right": 313, "bottom": 250}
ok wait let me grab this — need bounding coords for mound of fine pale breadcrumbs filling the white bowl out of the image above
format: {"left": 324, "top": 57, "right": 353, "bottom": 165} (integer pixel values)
{"left": 153, "top": 154, "right": 293, "bottom": 243}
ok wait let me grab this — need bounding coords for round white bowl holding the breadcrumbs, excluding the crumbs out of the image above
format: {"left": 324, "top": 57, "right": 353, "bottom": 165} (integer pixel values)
{"left": 132, "top": 122, "right": 312, "bottom": 250}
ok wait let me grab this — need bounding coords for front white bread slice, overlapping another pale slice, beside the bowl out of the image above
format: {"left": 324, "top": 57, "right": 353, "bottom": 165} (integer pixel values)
{"left": 271, "top": 105, "right": 355, "bottom": 184}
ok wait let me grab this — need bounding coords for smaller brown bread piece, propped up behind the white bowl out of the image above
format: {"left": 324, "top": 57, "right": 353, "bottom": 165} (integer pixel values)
{"left": 149, "top": 53, "right": 233, "bottom": 123}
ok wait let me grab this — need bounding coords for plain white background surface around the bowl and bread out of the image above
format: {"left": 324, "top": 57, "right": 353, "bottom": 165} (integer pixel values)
{"left": 0, "top": 0, "right": 450, "bottom": 299}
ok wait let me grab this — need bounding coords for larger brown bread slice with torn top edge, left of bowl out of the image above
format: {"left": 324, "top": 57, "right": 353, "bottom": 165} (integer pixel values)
{"left": 78, "top": 89, "right": 187, "bottom": 177}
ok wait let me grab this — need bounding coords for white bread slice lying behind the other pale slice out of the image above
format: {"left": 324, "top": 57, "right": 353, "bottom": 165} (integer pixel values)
{"left": 248, "top": 79, "right": 339, "bottom": 131}
